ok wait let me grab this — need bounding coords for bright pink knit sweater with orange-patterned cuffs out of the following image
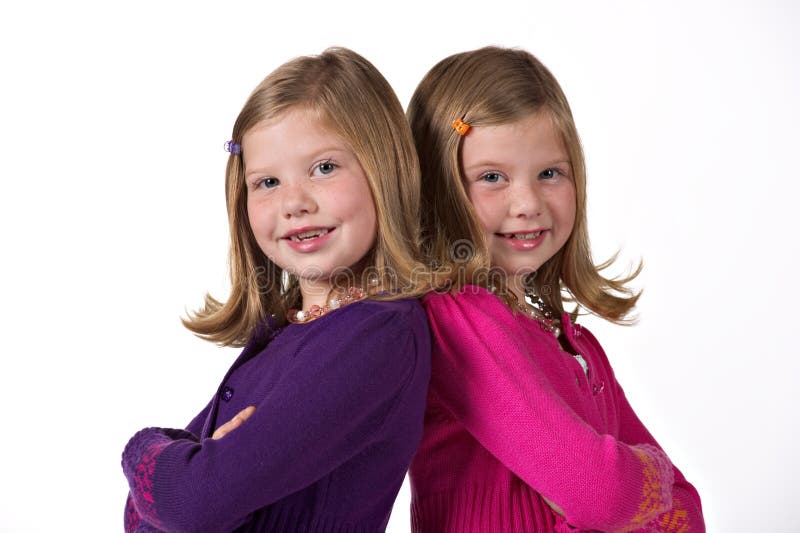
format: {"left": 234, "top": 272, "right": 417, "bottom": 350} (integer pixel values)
{"left": 410, "top": 286, "right": 705, "bottom": 533}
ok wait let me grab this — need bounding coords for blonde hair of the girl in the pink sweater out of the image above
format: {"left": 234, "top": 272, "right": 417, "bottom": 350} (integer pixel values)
{"left": 407, "top": 47, "right": 641, "bottom": 324}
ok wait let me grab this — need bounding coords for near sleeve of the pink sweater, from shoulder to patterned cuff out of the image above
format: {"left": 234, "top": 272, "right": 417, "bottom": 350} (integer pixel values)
{"left": 425, "top": 287, "right": 673, "bottom": 531}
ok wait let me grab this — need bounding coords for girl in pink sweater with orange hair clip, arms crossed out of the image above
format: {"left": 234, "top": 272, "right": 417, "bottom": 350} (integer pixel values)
{"left": 408, "top": 47, "right": 705, "bottom": 533}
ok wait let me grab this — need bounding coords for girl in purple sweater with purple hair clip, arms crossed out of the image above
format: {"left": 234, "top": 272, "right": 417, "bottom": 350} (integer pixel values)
{"left": 122, "top": 49, "right": 430, "bottom": 533}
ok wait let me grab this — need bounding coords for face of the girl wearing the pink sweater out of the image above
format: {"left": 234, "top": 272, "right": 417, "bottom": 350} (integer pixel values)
{"left": 461, "top": 113, "right": 575, "bottom": 287}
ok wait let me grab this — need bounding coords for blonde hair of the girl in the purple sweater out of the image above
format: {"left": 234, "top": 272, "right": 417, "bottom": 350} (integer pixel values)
{"left": 183, "top": 48, "right": 425, "bottom": 346}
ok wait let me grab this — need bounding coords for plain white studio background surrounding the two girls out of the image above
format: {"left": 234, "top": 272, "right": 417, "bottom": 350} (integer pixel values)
{"left": 0, "top": 0, "right": 800, "bottom": 532}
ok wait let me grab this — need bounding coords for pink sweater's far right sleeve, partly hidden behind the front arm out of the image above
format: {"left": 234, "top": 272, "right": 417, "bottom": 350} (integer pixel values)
{"left": 614, "top": 381, "right": 706, "bottom": 533}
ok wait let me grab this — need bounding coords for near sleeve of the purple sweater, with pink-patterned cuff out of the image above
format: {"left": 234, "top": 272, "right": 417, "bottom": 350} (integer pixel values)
{"left": 122, "top": 302, "right": 428, "bottom": 531}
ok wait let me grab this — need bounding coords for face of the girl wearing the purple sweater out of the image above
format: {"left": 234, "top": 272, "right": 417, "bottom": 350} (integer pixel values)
{"left": 242, "top": 109, "right": 377, "bottom": 300}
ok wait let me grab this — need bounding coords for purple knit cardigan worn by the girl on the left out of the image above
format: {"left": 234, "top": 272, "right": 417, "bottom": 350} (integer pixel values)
{"left": 122, "top": 300, "right": 430, "bottom": 533}
